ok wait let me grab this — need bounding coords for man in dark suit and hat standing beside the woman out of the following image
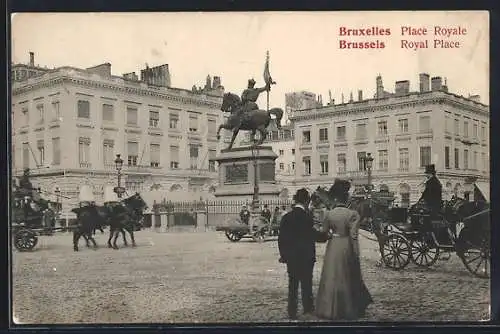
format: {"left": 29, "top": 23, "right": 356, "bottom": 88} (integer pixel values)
{"left": 278, "top": 188, "right": 328, "bottom": 320}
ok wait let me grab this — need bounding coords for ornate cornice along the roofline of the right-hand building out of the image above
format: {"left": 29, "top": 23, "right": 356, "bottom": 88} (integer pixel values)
{"left": 290, "top": 96, "right": 489, "bottom": 121}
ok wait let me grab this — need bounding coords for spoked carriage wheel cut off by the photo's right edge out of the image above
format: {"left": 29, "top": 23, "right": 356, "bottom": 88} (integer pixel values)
{"left": 457, "top": 236, "right": 491, "bottom": 278}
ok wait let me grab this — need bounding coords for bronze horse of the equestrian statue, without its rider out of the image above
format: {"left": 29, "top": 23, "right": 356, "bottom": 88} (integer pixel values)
{"left": 217, "top": 93, "right": 283, "bottom": 150}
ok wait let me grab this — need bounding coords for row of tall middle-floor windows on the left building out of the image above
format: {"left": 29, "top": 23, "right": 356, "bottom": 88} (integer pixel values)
{"left": 18, "top": 137, "right": 216, "bottom": 171}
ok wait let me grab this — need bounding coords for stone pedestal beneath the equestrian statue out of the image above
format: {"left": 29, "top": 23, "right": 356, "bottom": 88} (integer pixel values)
{"left": 214, "top": 146, "right": 281, "bottom": 201}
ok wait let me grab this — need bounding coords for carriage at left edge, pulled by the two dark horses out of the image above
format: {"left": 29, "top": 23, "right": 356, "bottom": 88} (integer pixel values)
{"left": 11, "top": 189, "right": 59, "bottom": 251}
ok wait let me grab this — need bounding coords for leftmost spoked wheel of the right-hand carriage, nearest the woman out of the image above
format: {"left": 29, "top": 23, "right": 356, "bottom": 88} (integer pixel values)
{"left": 382, "top": 234, "right": 411, "bottom": 270}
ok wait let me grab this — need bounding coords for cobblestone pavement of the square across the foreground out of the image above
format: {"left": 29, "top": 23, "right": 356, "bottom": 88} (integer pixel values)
{"left": 12, "top": 231, "right": 489, "bottom": 324}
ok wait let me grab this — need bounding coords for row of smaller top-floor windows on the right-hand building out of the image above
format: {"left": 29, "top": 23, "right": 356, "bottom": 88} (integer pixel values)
{"left": 302, "top": 116, "right": 486, "bottom": 143}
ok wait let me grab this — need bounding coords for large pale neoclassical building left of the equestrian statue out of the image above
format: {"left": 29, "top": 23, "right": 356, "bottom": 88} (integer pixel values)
{"left": 12, "top": 53, "right": 227, "bottom": 218}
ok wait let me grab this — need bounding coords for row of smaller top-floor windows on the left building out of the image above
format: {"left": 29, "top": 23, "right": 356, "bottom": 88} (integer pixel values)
{"left": 21, "top": 100, "right": 217, "bottom": 134}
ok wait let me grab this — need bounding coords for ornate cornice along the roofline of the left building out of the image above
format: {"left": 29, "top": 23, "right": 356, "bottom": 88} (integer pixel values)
{"left": 12, "top": 75, "right": 222, "bottom": 109}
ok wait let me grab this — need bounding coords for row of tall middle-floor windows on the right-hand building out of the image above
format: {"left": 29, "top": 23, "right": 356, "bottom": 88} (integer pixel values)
{"left": 302, "top": 146, "right": 488, "bottom": 175}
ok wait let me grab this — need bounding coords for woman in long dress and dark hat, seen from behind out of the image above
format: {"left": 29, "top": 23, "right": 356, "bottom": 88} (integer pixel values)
{"left": 316, "top": 180, "right": 372, "bottom": 320}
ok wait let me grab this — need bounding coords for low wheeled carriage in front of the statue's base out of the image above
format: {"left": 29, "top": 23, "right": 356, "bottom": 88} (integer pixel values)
{"left": 216, "top": 215, "right": 279, "bottom": 242}
